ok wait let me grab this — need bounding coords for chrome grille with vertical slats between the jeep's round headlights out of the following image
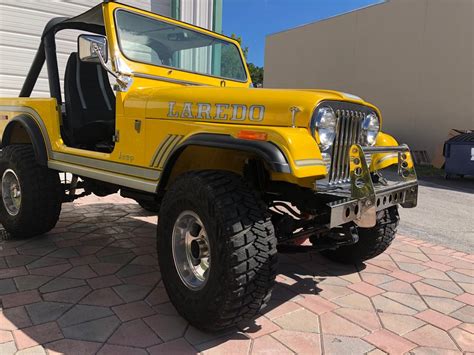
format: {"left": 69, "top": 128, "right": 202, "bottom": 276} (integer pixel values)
{"left": 329, "top": 109, "right": 365, "bottom": 185}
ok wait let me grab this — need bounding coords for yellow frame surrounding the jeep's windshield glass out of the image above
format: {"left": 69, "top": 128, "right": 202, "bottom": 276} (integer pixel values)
{"left": 113, "top": 7, "right": 249, "bottom": 84}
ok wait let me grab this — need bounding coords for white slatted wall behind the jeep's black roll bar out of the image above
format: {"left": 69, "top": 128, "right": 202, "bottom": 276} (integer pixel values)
{"left": 0, "top": 0, "right": 151, "bottom": 97}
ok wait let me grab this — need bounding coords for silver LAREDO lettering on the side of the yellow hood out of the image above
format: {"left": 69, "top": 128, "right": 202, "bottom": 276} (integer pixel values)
{"left": 168, "top": 102, "right": 265, "bottom": 122}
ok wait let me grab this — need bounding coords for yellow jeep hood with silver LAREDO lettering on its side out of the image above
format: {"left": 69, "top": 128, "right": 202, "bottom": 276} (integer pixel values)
{"left": 133, "top": 86, "right": 377, "bottom": 127}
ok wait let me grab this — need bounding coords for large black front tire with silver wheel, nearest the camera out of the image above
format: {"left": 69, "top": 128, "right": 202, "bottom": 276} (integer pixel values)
{"left": 158, "top": 171, "right": 277, "bottom": 331}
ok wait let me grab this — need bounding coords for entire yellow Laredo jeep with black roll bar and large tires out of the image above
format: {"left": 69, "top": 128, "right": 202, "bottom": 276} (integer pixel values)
{"left": 0, "top": 1, "right": 418, "bottom": 330}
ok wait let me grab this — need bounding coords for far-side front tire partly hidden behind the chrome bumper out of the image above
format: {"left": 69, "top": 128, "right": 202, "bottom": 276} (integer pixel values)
{"left": 321, "top": 206, "right": 400, "bottom": 264}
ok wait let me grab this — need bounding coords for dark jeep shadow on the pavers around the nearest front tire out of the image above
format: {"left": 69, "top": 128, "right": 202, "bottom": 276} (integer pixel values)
{"left": 0, "top": 199, "right": 370, "bottom": 354}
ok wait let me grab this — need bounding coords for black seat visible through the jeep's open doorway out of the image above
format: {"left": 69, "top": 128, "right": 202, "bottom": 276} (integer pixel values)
{"left": 64, "top": 53, "right": 115, "bottom": 150}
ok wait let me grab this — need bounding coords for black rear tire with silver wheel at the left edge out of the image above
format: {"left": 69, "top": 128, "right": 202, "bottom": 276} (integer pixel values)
{"left": 0, "top": 145, "right": 64, "bottom": 238}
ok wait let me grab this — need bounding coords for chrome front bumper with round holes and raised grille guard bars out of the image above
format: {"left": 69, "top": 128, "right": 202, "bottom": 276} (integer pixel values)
{"left": 326, "top": 145, "right": 418, "bottom": 228}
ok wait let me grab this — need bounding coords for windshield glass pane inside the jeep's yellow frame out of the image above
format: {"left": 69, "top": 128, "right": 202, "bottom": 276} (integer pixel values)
{"left": 116, "top": 10, "right": 247, "bottom": 81}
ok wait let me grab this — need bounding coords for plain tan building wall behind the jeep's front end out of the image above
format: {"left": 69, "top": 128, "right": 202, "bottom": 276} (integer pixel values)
{"left": 265, "top": 0, "right": 474, "bottom": 158}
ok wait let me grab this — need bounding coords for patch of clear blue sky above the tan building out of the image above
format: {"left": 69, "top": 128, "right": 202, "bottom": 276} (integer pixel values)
{"left": 222, "top": 0, "right": 382, "bottom": 66}
